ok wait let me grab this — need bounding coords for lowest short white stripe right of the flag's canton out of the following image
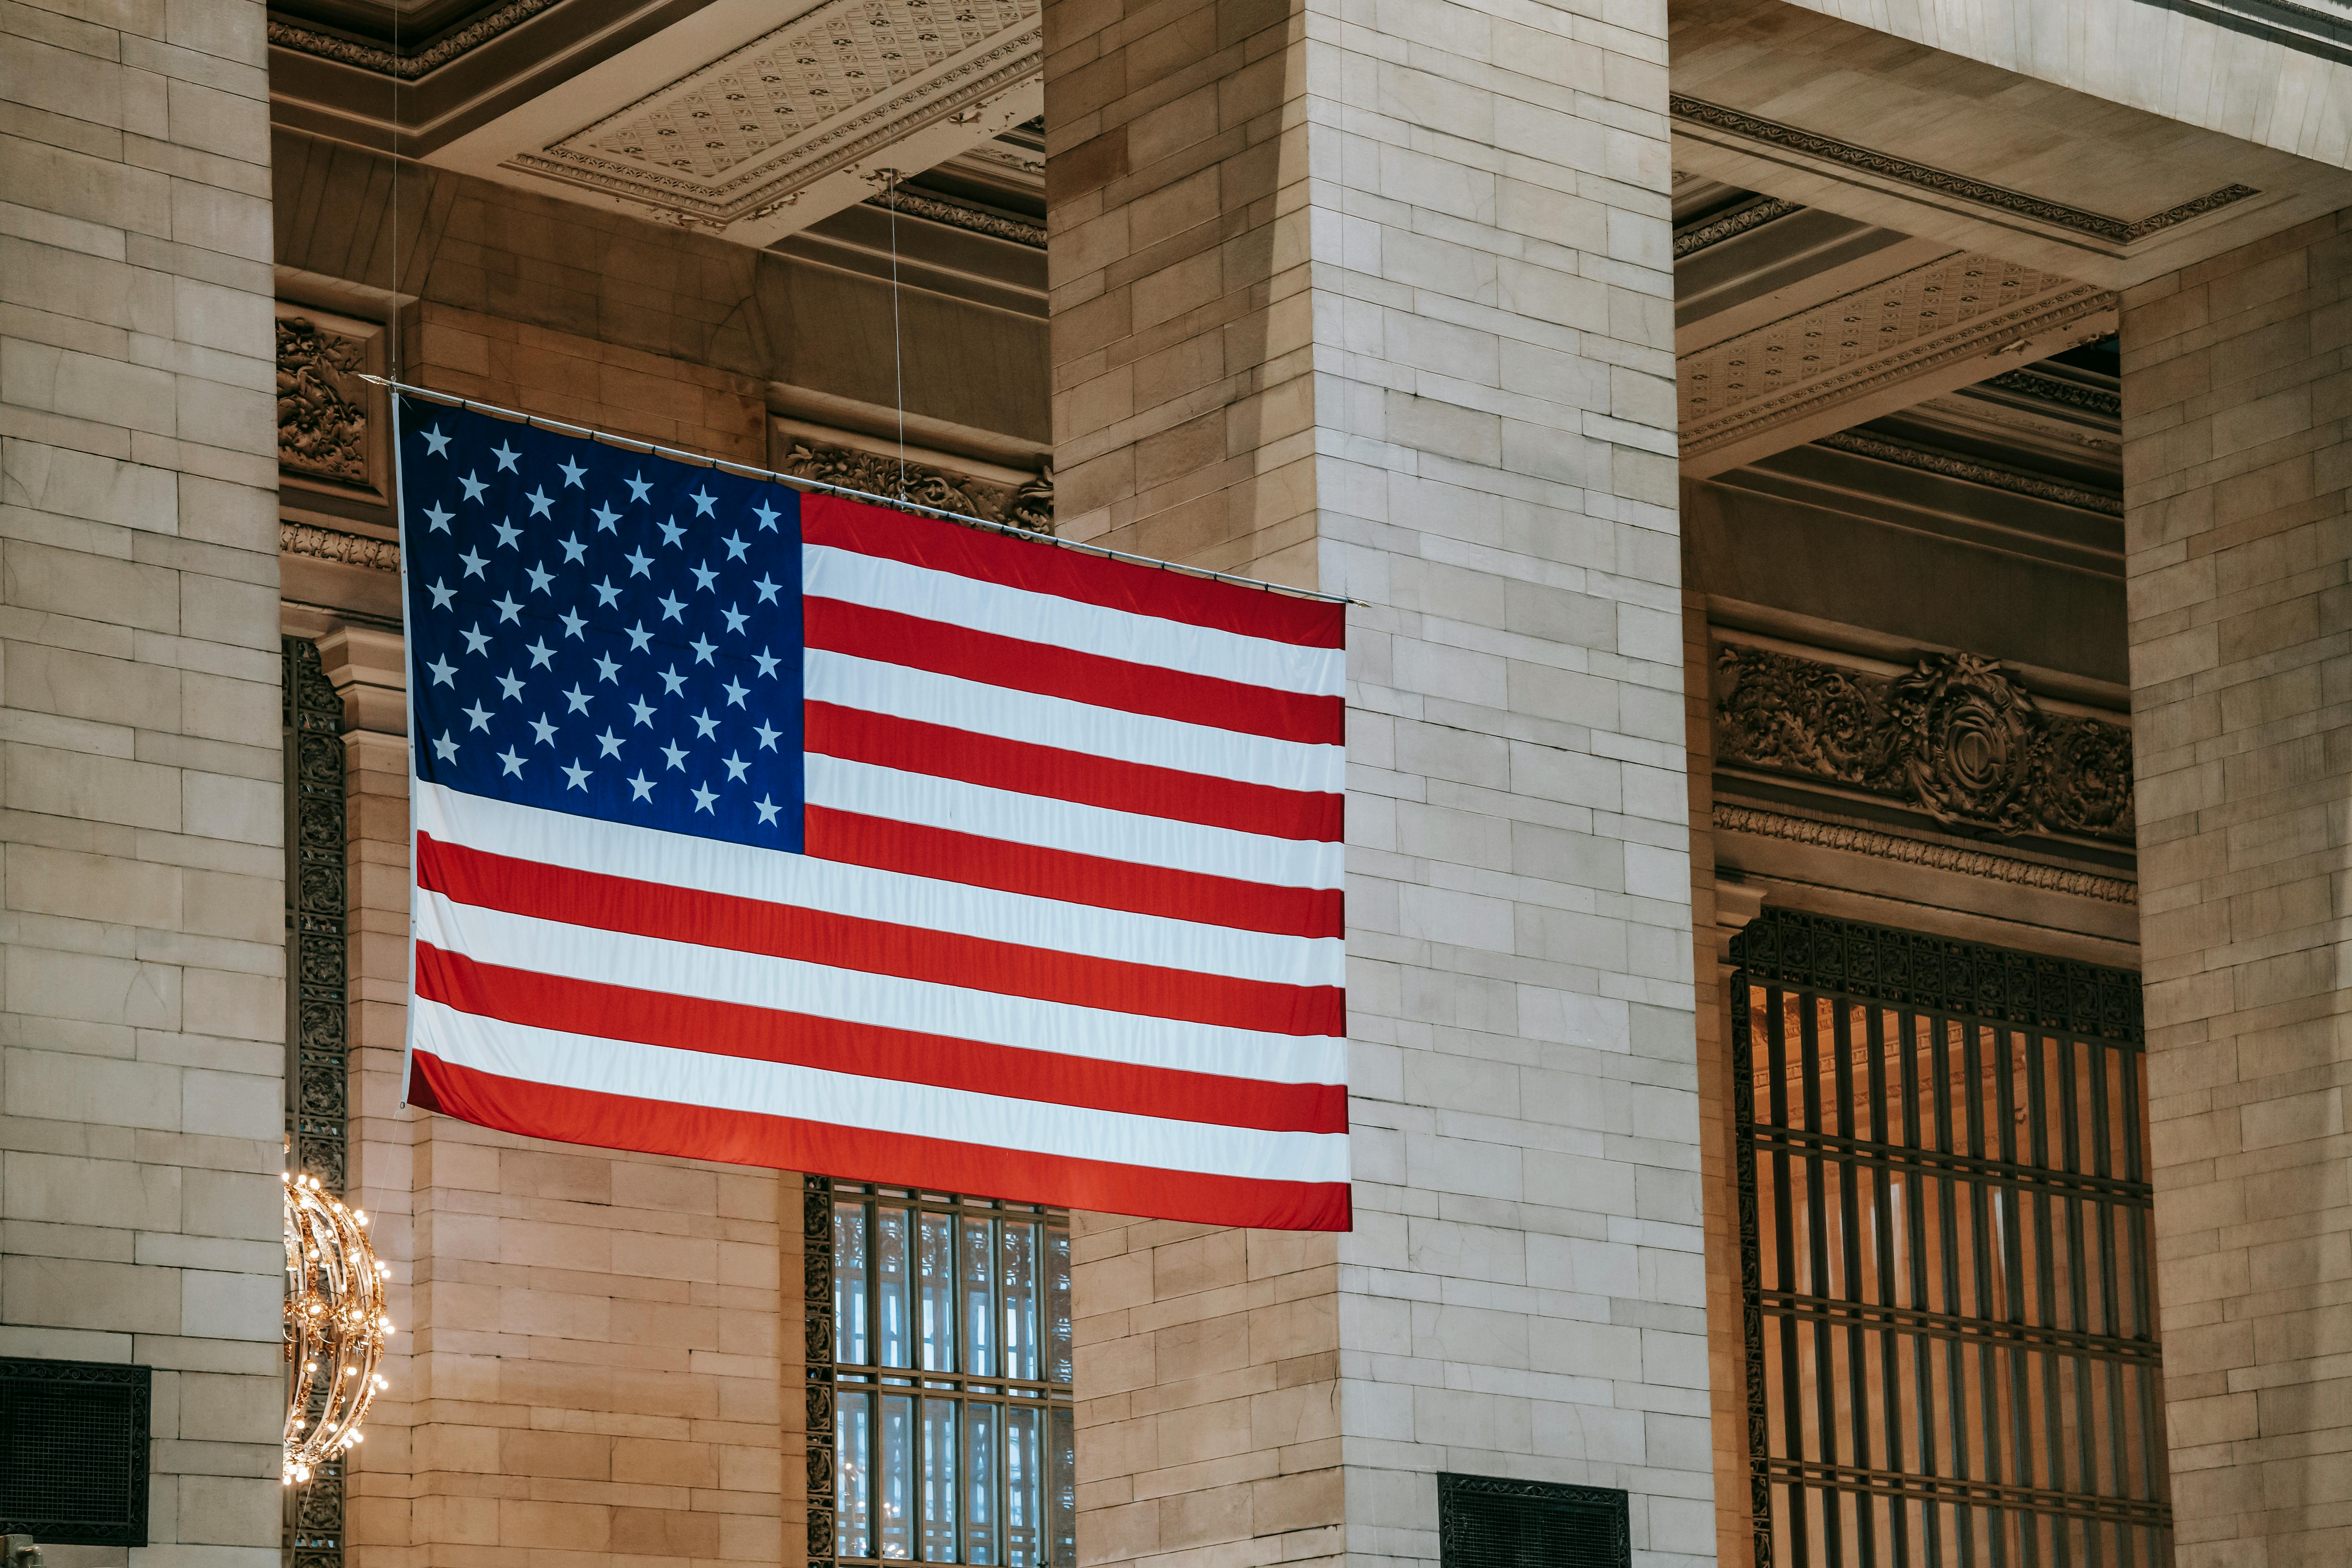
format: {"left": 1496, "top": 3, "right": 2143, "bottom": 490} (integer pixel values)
{"left": 802, "top": 752, "right": 1348, "bottom": 889}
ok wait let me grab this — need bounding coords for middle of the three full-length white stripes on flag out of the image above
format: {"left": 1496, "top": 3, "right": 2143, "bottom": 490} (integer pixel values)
{"left": 414, "top": 889, "right": 1348, "bottom": 1084}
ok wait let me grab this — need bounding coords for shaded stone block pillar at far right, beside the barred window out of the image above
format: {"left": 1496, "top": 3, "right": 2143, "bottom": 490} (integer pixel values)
{"left": 2124, "top": 214, "right": 2352, "bottom": 1568}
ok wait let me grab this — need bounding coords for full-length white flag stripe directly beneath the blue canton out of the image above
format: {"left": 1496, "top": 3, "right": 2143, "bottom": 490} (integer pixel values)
{"left": 416, "top": 783, "right": 1348, "bottom": 985}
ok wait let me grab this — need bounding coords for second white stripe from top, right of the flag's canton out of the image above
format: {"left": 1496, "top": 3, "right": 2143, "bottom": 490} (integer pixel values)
{"left": 802, "top": 649, "right": 1345, "bottom": 795}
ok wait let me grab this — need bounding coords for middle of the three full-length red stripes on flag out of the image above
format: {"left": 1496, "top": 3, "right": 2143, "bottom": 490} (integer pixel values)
{"left": 416, "top": 943, "right": 1348, "bottom": 1133}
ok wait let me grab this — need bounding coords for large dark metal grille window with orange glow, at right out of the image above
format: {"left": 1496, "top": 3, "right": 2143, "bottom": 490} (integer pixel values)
{"left": 1731, "top": 910, "right": 2171, "bottom": 1568}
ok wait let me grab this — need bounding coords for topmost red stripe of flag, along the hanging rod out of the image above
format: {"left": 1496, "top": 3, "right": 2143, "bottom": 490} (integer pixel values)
{"left": 800, "top": 494, "right": 1348, "bottom": 649}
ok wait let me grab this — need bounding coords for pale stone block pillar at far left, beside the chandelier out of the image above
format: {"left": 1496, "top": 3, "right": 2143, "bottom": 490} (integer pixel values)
{"left": 0, "top": 0, "right": 285, "bottom": 1568}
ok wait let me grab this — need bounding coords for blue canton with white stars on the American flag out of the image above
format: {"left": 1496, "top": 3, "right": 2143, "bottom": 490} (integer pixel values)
{"left": 400, "top": 397, "right": 802, "bottom": 851}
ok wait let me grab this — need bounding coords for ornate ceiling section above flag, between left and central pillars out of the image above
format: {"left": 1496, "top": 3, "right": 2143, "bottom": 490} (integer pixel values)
{"left": 270, "top": 0, "right": 1042, "bottom": 245}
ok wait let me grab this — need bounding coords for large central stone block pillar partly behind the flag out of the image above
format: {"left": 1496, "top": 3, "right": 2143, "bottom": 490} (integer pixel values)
{"left": 1044, "top": 0, "right": 1715, "bottom": 1563}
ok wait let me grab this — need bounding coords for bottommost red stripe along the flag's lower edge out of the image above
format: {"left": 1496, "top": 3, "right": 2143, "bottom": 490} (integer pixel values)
{"left": 409, "top": 1051, "right": 1350, "bottom": 1229}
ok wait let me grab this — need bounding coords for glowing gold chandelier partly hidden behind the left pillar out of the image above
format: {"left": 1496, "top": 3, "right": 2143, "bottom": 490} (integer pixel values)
{"left": 282, "top": 1173, "right": 393, "bottom": 1486}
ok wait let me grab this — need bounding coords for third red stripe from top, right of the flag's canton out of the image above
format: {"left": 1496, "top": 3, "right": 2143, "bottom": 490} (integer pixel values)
{"left": 802, "top": 703, "right": 1343, "bottom": 844}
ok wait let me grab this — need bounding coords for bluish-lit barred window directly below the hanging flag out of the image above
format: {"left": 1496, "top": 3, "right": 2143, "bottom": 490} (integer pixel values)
{"left": 804, "top": 1176, "right": 1077, "bottom": 1568}
